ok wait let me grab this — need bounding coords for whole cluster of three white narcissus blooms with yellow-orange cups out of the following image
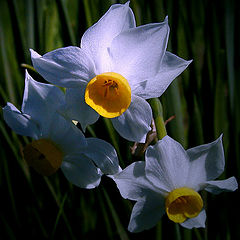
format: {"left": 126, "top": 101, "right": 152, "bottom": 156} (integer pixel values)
{"left": 3, "top": 2, "right": 237, "bottom": 232}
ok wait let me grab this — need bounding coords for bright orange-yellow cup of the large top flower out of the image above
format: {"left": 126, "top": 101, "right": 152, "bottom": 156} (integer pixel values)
{"left": 85, "top": 72, "right": 131, "bottom": 118}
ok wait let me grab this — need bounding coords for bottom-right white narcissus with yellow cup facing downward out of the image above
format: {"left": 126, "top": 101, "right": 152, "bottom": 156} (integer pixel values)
{"left": 113, "top": 136, "right": 238, "bottom": 232}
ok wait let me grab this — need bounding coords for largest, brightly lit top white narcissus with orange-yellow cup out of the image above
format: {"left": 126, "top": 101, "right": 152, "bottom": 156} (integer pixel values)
{"left": 31, "top": 2, "right": 191, "bottom": 142}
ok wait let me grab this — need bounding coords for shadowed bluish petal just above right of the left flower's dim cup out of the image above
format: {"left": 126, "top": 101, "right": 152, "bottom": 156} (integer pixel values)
{"left": 47, "top": 113, "right": 87, "bottom": 155}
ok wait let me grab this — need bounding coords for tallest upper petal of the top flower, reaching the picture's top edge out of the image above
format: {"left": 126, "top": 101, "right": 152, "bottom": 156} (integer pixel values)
{"left": 81, "top": 2, "right": 135, "bottom": 74}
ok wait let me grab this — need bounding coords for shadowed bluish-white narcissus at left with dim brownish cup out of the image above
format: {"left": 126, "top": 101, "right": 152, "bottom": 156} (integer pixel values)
{"left": 3, "top": 72, "right": 121, "bottom": 188}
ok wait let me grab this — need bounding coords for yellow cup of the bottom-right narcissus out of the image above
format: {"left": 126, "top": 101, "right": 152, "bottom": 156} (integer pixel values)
{"left": 165, "top": 187, "right": 203, "bottom": 223}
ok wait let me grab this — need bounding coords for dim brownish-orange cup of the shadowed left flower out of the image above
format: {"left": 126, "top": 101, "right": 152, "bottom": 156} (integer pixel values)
{"left": 23, "top": 139, "right": 63, "bottom": 176}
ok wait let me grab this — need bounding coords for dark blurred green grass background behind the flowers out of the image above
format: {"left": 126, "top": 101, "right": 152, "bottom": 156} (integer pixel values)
{"left": 0, "top": 0, "right": 240, "bottom": 240}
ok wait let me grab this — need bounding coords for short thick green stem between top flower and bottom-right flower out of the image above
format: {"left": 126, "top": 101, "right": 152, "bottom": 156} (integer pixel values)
{"left": 149, "top": 98, "right": 167, "bottom": 140}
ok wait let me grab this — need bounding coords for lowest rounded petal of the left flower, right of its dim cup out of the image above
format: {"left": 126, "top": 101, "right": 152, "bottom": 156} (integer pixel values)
{"left": 61, "top": 154, "right": 102, "bottom": 189}
